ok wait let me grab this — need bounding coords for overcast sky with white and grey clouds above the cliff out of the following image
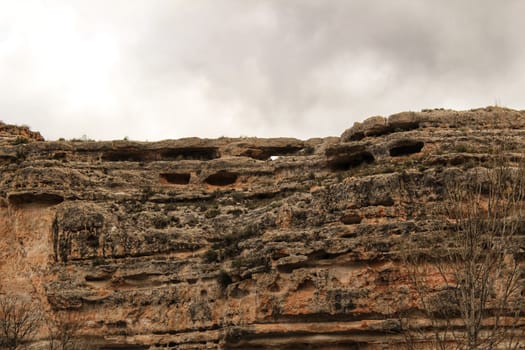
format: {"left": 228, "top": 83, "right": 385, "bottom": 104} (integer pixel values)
{"left": 0, "top": 0, "right": 525, "bottom": 140}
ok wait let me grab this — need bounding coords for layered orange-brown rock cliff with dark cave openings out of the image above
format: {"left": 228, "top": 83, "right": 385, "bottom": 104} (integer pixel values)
{"left": 0, "top": 107, "right": 525, "bottom": 349}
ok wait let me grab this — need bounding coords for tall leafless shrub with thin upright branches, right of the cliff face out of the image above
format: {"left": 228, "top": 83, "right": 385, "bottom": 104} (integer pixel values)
{"left": 400, "top": 161, "right": 525, "bottom": 350}
